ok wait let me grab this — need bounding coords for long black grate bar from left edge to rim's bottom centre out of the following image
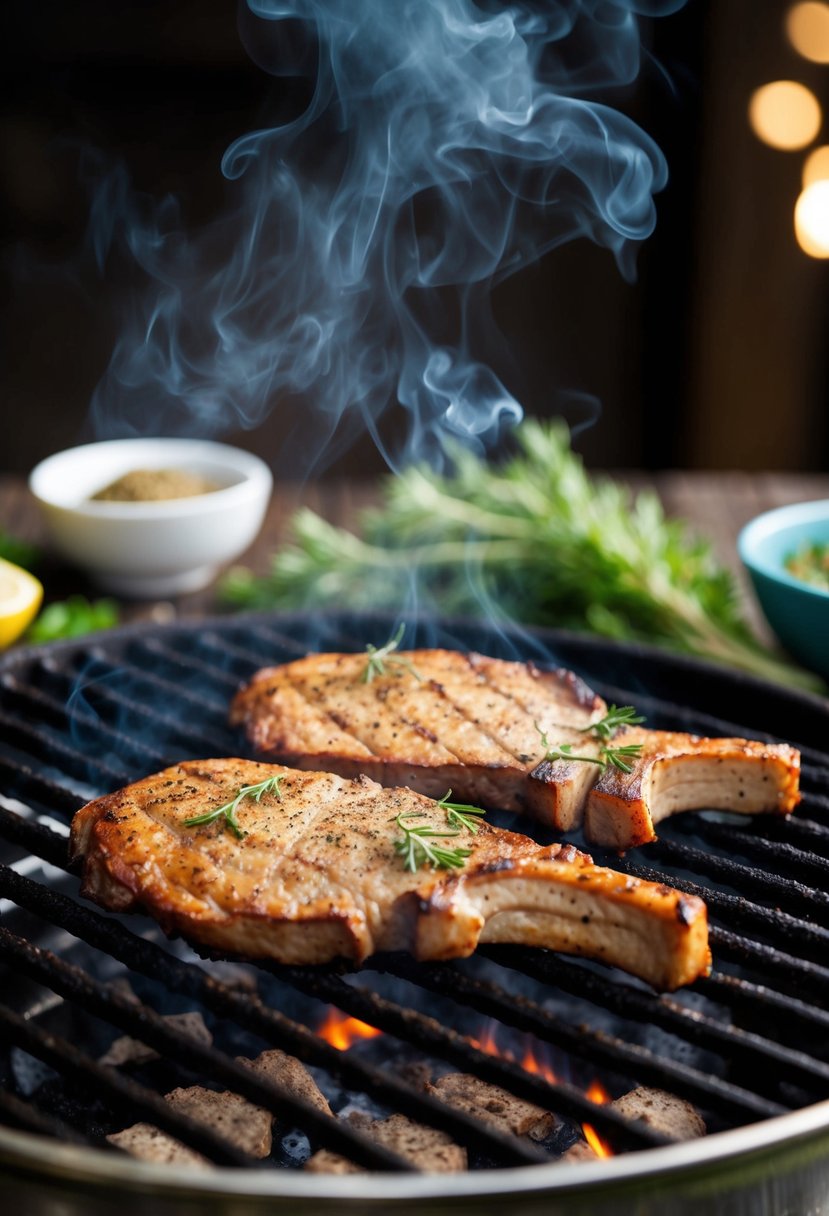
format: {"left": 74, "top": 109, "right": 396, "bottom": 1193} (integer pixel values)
{"left": 0, "top": 928, "right": 412, "bottom": 1171}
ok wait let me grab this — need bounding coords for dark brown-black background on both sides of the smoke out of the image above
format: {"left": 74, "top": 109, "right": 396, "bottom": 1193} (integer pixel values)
{"left": 0, "top": 0, "right": 829, "bottom": 473}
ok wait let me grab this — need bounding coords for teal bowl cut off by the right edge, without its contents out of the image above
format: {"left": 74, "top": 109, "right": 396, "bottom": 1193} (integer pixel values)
{"left": 737, "top": 500, "right": 829, "bottom": 679}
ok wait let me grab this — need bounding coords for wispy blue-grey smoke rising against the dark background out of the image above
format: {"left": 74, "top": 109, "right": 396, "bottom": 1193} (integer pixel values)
{"left": 90, "top": 0, "right": 682, "bottom": 472}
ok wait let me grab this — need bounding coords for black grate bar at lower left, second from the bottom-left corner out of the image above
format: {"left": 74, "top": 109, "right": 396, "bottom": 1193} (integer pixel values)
{"left": 0, "top": 1004, "right": 259, "bottom": 1166}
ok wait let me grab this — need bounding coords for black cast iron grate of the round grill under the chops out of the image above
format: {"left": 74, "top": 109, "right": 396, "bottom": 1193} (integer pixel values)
{"left": 0, "top": 614, "right": 829, "bottom": 1170}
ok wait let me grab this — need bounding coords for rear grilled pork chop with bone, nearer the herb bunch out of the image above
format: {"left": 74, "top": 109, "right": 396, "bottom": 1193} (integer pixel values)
{"left": 231, "top": 651, "right": 800, "bottom": 849}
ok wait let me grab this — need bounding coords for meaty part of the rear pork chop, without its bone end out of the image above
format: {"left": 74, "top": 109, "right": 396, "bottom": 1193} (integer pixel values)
{"left": 231, "top": 651, "right": 607, "bottom": 828}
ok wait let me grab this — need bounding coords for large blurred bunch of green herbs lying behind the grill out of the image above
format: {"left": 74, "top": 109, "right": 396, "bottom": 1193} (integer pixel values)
{"left": 222, "top": 418, "right": 823, "bottom": 688}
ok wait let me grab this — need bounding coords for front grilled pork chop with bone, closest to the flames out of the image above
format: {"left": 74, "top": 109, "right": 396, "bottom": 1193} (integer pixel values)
{"left": 71, "top": 760, "right": 709, "bottom": 989}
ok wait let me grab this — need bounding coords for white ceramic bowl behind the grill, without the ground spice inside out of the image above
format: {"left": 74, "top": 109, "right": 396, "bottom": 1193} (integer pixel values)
{"left": 29, "top": 439, "right": 272, "bottom": 598}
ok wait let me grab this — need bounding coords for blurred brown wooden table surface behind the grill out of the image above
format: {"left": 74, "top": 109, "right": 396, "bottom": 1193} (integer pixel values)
{"left": 0, "top": 472, "right": 829, "bottom": 632}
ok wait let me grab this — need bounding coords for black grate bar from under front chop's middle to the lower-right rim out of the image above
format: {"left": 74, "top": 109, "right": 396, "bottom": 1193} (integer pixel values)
{"left": 374, "top": 947, "right": 792, "bottom": 1121}
